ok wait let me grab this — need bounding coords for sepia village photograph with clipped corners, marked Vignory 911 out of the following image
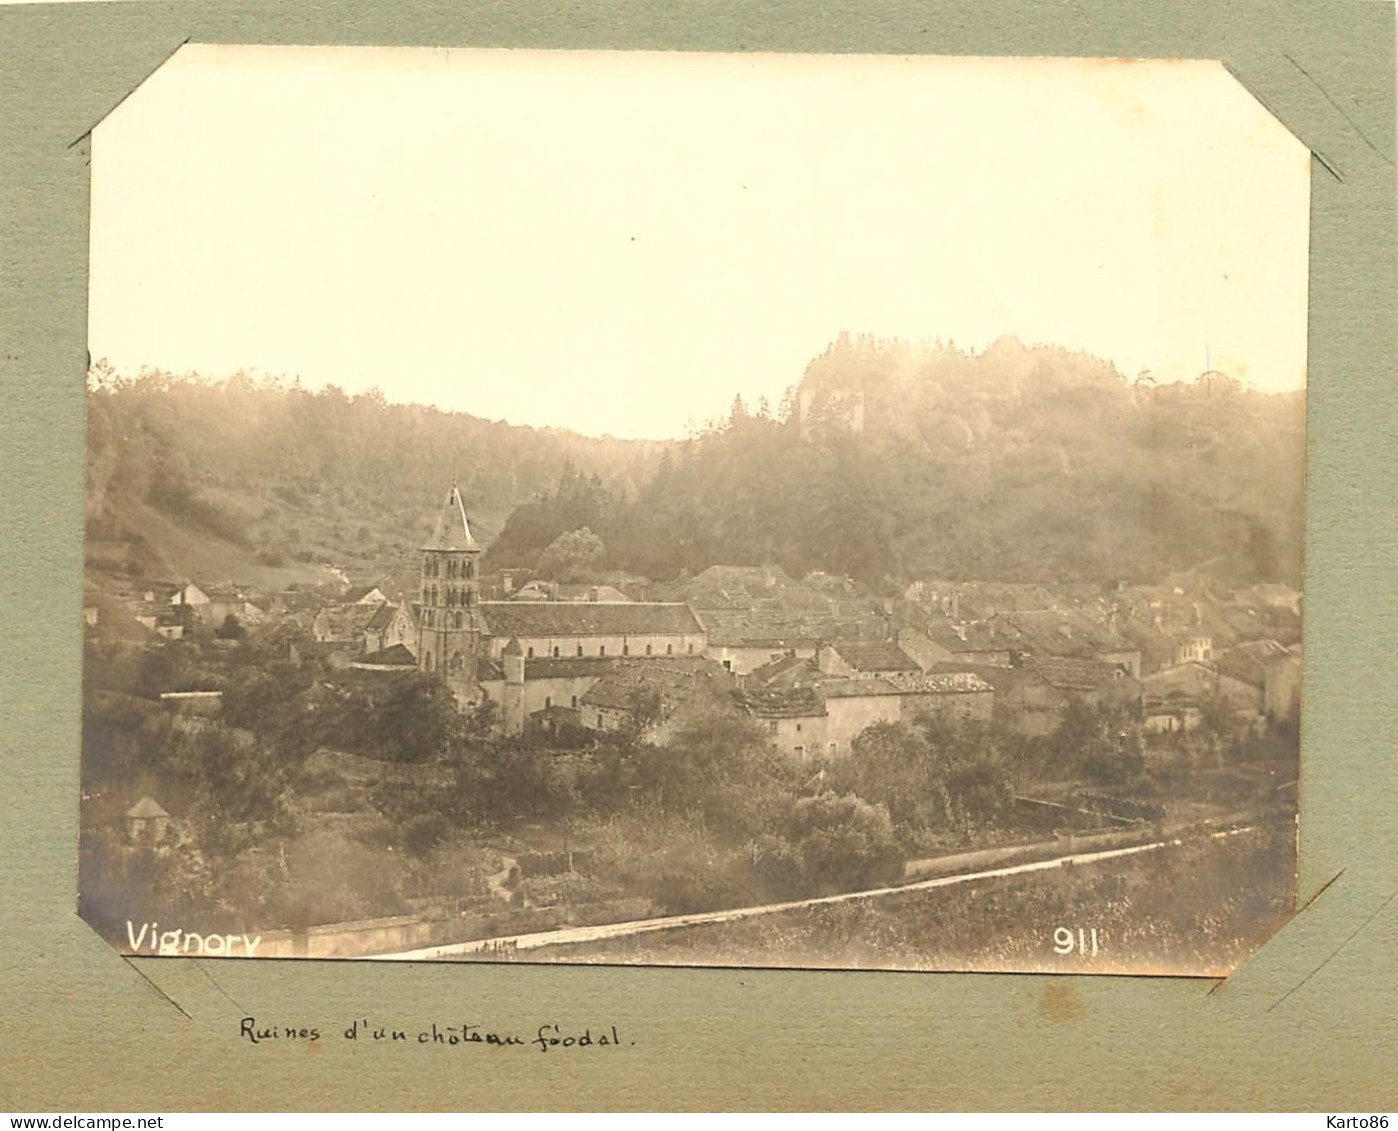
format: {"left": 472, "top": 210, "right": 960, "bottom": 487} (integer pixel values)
{"left": 74, "top": 43, "right": 1310, "bottom": 977}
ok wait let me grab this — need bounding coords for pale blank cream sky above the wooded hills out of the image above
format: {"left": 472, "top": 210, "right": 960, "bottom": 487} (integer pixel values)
{"left": 88, "top": 45, "right": 1310, "bottom": 439}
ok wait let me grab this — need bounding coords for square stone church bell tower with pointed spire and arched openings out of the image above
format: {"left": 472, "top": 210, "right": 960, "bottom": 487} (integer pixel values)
{"left": 418, "top": 481, "right": 481, "bottom": 706}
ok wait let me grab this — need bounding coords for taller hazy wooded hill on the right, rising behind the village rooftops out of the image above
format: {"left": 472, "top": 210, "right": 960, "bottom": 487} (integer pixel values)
{"left": 493, "top": 337, "right": 1304, "bottom": 587}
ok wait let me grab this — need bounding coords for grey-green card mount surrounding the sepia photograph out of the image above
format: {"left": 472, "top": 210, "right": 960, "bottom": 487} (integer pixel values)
{"left": 0, "top": 0, "right": 1398, "bottom": 1111}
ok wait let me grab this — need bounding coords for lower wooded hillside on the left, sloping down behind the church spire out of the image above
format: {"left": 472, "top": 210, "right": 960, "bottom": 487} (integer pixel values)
{"left": 87, "top": 363, "right": 660, "bottom": 584}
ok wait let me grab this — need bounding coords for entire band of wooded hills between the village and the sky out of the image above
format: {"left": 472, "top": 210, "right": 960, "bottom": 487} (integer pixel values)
{"left": 88, "top": 336, "right": 1304, "bottom": 590}
